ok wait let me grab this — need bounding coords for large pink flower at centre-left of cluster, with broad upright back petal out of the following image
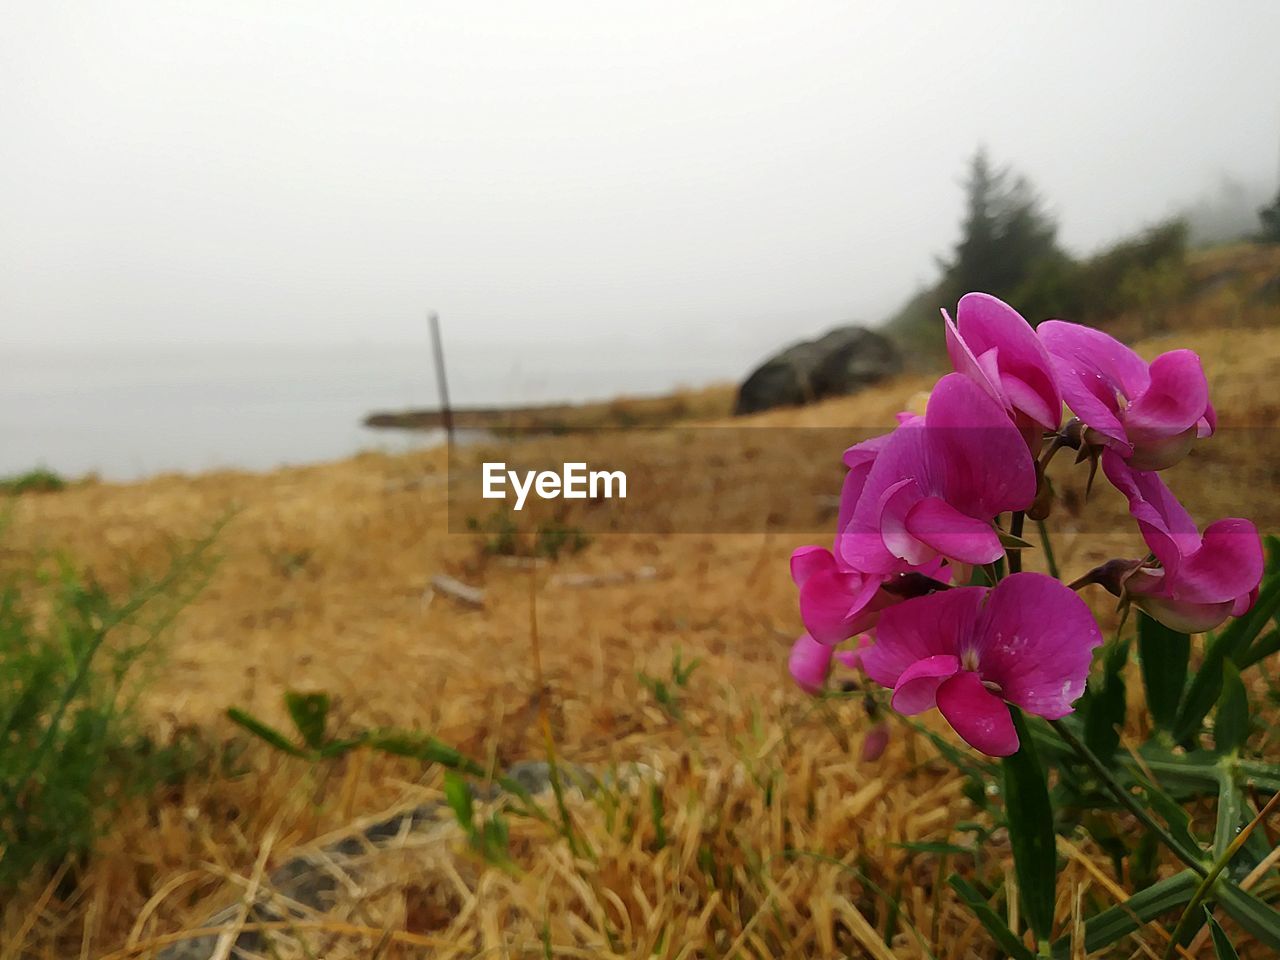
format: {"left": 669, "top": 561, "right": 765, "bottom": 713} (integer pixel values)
{"left": 836, "top": 374, "right": 1036, "bottom": 575}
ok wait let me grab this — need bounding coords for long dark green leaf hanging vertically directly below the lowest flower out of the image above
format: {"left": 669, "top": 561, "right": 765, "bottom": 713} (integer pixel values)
{"left": 1001, "top": 707, "right": 1057, "bottom": 942}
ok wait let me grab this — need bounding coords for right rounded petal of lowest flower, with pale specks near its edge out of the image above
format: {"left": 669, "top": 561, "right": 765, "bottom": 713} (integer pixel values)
{"left": 974, "top": 573, "right": 1102, "bottom": 719}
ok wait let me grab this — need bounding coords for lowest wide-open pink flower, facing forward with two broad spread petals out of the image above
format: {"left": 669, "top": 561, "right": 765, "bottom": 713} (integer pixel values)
{"left": 863, "top": 573, "right": 1102, "bottom": 756}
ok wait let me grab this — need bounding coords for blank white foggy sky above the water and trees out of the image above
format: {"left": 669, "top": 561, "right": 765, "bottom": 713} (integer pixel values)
{"left": 0, "top": 0, "right": 1280, "bottom": 343}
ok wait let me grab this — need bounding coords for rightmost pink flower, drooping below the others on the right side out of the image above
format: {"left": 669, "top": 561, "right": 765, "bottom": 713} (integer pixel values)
{"left": 1102, "top": 451, "right": 1263, "bottom": 634}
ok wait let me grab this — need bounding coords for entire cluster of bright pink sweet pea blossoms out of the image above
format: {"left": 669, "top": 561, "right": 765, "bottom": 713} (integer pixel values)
{"left": 790, "top": 293, "right": 1262, "bottom": 756}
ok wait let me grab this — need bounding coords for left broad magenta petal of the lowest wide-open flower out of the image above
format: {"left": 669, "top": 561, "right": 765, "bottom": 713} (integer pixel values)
{"left": 863, "top": 586, "right": 987, "bottom": 687}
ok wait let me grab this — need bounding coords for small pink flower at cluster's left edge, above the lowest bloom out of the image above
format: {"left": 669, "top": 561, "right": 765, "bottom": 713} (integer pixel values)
{"left": 791, "top": 547, "right": 941, "bottom": 646}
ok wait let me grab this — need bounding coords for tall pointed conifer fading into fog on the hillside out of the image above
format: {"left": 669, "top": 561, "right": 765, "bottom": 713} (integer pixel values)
{"left": 942, "top": 147, "right": 1065, "bottom": 309}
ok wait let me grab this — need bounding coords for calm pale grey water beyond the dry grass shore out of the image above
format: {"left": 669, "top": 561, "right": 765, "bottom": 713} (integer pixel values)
{"left": 0, "top": 333, "right": 767, "bottom": 480}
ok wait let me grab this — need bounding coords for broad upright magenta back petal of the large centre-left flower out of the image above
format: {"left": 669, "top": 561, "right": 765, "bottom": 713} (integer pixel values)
{"left": 923, "top": 374, "right": 1036, "bottom": 520}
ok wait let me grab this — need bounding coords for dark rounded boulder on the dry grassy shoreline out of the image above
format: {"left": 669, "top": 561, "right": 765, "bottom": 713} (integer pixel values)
{"left": 733, "top": 326, "right": 902, "bottom": 416}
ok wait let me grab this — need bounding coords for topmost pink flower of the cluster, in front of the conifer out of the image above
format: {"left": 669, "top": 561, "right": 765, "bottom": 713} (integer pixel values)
{"left": 942, "top": 293, "right": 1062, "bottom": 449}
